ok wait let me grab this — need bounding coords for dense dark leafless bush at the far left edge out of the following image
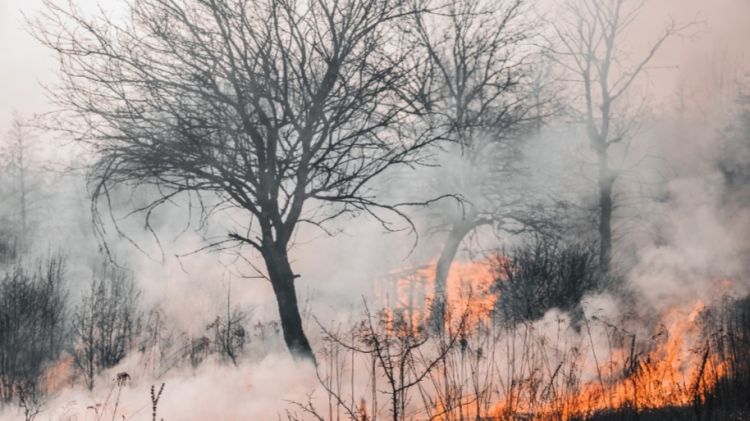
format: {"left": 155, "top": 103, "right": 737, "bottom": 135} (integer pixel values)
{"left": 0, "top": 257, "right": 67, "bottom": 402}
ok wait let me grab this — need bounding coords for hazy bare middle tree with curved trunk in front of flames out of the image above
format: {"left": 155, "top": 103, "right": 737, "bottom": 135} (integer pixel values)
{"left": 406, "top": 0, "right": 544, "bottom": 328}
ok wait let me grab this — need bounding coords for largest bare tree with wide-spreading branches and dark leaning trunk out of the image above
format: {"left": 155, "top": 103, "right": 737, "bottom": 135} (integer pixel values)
{"left": 35, "top": 0, "right": 434, "bottom": 359}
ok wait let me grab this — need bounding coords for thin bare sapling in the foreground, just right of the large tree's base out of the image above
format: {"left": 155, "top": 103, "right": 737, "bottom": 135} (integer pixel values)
{"left": 287, "top": 304, "right": 468, "bottom": 421}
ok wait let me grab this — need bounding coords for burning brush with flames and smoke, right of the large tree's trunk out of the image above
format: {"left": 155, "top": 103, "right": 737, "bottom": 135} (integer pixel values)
{"left": 306, "top": 257, "right": 750, "bottom": 420}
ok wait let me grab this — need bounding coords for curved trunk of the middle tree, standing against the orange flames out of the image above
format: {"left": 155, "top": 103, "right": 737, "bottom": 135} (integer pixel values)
{"left": 430, "top": 218, "right": 475, "bottom": 333}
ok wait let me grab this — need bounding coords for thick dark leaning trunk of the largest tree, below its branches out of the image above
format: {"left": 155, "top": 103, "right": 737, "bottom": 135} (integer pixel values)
{"left": 262, "top": 248, "right": 315, "bottom": 363}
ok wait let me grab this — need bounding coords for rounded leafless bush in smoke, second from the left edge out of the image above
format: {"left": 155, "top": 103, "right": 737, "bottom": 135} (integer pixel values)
{"left": 71, "top": 267, "right": 141, "bottom": 389}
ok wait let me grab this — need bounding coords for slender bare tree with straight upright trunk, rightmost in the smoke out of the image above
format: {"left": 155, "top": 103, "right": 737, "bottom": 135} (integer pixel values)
{"left": 551, "top": 0, "right": 681, "bottom": 273}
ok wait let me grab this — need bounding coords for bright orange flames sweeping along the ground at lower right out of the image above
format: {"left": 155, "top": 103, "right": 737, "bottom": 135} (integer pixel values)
{"left": 493, "top": 301, "right": 725, "bottom": 420}
